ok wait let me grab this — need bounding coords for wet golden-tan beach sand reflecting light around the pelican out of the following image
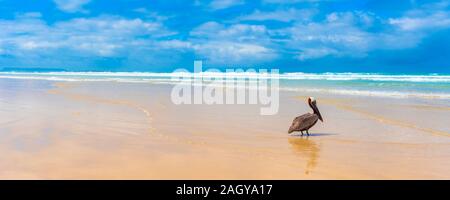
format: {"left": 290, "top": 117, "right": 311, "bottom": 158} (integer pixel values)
{"left": 0, "top": 79, "right": 450, "bottom": 179}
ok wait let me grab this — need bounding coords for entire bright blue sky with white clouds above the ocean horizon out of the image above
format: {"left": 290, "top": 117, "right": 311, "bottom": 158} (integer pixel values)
{"left": 0, "top": 0, "right": 450, "bottom": 73}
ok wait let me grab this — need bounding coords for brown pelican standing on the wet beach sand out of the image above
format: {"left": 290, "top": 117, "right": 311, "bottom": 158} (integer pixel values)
{"left": 288, "top": 97, "right": 323, "bottom": 135}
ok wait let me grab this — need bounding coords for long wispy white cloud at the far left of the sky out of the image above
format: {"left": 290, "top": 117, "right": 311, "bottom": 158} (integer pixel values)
{"left": 0, "top": 16, "right": 174, "bottom": 56}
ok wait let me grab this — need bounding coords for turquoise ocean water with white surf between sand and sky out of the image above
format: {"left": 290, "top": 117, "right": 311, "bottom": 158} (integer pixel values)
{"left": 0, "top": 72, "right": 450, "bottom": 100}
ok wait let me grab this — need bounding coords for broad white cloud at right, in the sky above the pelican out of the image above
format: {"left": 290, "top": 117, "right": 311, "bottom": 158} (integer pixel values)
{"left": 276, "top": 7, "right": 447, "bottom": 61}
